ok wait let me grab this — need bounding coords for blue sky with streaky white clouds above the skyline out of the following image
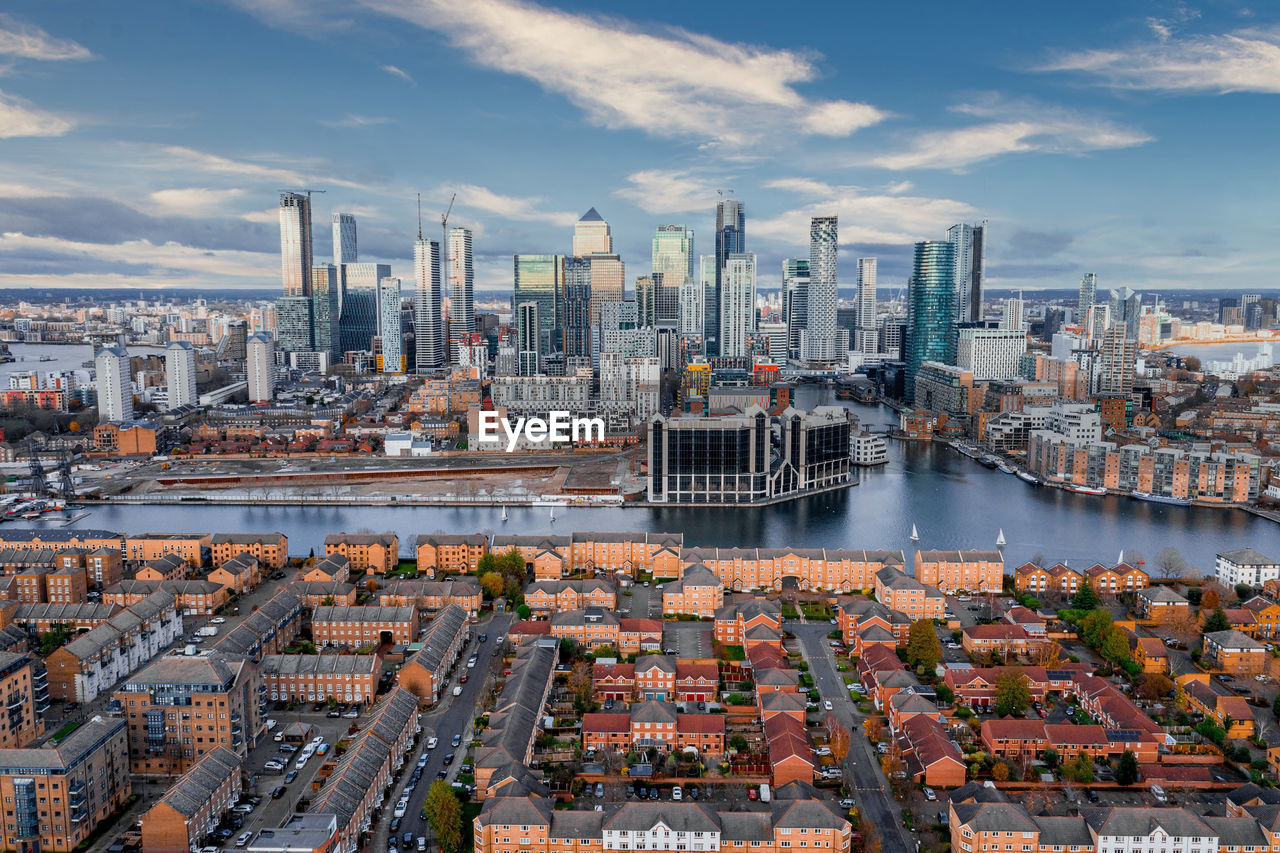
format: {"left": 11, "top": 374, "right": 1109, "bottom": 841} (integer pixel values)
{"left": 0, "top": 0, "right": 1280, "bottom": 298}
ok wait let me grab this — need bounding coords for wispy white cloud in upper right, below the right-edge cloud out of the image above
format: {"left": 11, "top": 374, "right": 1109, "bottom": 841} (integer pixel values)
{"left": 870, "top": 97, "right": 1152, "bottom": 170}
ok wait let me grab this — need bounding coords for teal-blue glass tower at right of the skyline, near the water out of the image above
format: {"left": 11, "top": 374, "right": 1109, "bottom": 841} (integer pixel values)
{"left": 902, "top": 240, "right": 956, "bottom": 391}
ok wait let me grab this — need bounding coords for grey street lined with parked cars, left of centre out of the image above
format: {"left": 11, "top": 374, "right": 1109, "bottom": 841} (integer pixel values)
{"left": 371, "top": 613, "right": 512, "bottom": 850}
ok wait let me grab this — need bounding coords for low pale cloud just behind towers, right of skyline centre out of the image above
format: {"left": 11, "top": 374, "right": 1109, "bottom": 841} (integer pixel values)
{"left": 750, "top": 178, "right": 975, "bottom": 246}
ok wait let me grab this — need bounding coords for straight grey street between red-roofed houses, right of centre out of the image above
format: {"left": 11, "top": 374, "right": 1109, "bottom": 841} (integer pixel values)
{"left": 787, "top": 620, "right": 916, "bottom": 853}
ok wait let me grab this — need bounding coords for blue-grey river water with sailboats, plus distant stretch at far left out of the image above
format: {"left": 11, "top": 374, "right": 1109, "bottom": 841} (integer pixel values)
{"left": 0, "top": 345, "right": 1280, "bottom": 573}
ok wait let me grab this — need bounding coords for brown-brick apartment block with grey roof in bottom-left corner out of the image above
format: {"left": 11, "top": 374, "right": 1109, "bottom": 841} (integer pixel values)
{"left": 0, "top": 717, "right": 131, "bottom": 852}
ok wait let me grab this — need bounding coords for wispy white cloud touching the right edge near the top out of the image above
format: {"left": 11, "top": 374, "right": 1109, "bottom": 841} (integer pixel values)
{"left": 1038, "top": 22, "right": 1280, "bottom": 95}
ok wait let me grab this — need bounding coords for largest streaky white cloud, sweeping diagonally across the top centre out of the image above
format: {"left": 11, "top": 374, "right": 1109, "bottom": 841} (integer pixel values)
{"left": 364, "top": 0, "right": 886, "bottom": 145}
